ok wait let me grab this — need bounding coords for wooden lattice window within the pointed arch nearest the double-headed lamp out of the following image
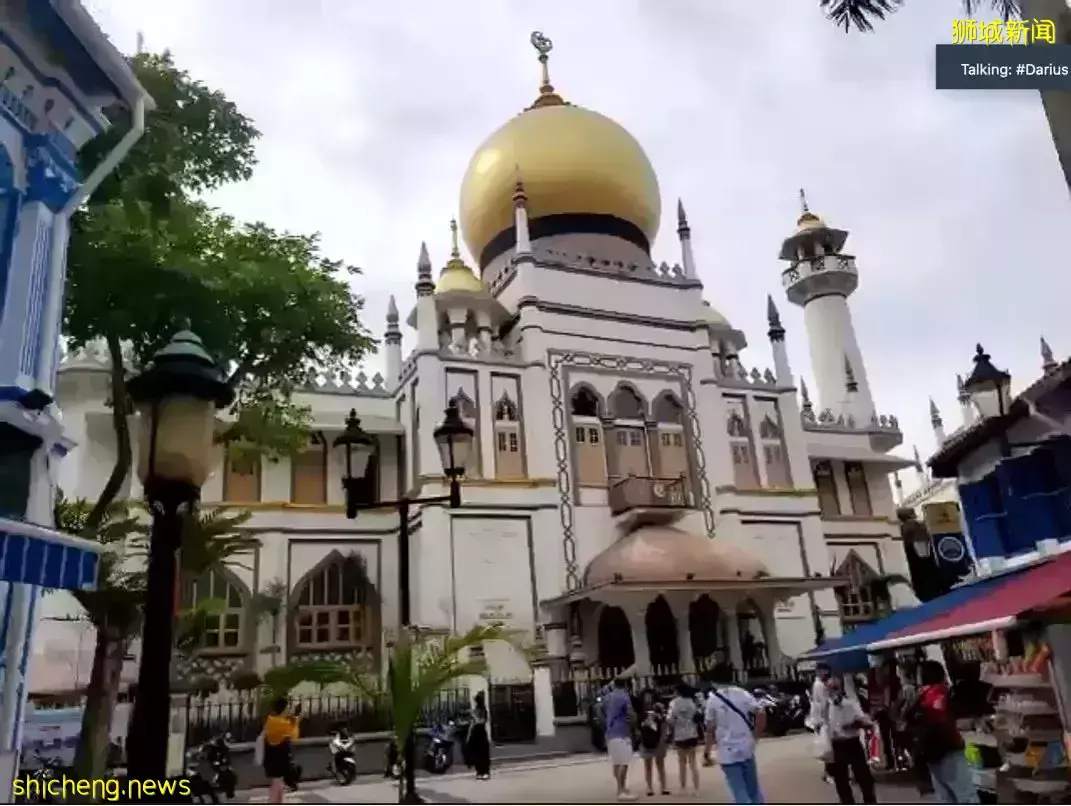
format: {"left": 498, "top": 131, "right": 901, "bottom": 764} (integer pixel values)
{"left": 295, "top": 554, "right": 379, "bottom": 651}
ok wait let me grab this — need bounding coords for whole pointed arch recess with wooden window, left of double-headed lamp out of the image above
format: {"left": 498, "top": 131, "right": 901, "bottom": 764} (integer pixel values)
{"left": 286, "top": 549, "right": 382, "bottom": 663}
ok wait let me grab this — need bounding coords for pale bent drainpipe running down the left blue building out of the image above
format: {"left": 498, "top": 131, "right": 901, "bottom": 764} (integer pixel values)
{"left": 36, "top": 92, "right": 149, "bottom": 392}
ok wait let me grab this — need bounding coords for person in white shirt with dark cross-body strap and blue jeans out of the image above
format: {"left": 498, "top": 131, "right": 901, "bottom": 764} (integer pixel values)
{"left": 706, "top": 670, "right": 766, "bottom": 803}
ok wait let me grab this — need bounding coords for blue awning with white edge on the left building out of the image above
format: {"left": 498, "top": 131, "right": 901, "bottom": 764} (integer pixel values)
{"left": 0, "top": 518, "right": 102, "bottom": 591}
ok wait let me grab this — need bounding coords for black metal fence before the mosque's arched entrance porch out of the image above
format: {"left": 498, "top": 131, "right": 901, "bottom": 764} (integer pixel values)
{"left": 553, "top": 664, "right": 809, "bottom": 717}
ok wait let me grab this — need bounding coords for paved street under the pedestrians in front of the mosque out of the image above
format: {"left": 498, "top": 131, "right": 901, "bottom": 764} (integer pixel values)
{"left": 242, "top": 736, "right": 929, "bottom": 804}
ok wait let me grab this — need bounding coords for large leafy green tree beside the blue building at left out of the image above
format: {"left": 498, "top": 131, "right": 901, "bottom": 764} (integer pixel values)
{"left": 64, "top": 52, "right": 374, "bottom": 777}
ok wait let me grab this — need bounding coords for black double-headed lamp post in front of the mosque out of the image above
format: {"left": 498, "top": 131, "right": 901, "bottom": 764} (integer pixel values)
{"left": 334, "top": 400, "right": 474, "bottom": 803}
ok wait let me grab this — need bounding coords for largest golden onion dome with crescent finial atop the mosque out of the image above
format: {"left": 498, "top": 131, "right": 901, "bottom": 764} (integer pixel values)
{"left": 461, "top": 34, "right": 662, "bottom": 267}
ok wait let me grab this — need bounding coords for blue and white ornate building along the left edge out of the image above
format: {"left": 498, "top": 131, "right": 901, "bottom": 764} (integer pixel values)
{"left": 0, "top": 0, "right": 152, "bottom": 801}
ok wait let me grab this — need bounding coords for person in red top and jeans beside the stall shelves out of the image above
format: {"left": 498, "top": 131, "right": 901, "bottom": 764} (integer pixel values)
{"left": 907, "top": 660, "right": 979, "bottom": 804}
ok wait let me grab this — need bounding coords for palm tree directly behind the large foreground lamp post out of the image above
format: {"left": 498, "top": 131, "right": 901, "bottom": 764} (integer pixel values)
{"left": 56, "top": 495, "right": 259, "bottom": 778}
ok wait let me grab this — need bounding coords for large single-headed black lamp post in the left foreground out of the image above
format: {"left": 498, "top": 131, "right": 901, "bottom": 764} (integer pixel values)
{"left": 126, "top": 330, "right": 235, "bottom": 780}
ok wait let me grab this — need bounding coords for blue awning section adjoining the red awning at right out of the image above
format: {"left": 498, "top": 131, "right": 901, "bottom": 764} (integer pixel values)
{"left": 799, "top": 571, "right": 1022, "bottom": 673}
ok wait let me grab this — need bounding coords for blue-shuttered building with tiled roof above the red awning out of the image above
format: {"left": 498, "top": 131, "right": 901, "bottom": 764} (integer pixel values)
{"left": 929, "top": 345, "right": 1071, "bottom": 574}
